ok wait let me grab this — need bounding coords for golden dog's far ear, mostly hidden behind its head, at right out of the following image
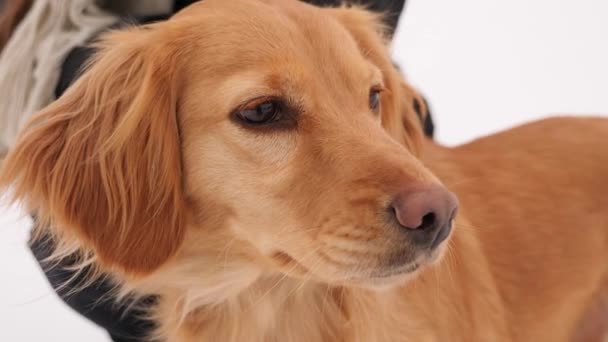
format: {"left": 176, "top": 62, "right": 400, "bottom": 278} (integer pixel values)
{"left": 328, "top": 6, "right": 422, "bottom": 154}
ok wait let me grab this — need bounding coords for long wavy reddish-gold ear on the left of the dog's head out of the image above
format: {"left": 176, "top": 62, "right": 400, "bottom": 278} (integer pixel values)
{"left": 0, "top": 27, "right": 185, "bottom": 274}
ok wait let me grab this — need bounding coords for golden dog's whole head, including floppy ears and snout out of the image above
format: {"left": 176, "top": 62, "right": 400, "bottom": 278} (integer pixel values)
{"left": 2, "top": 0, "right": 456, "bottom": 292}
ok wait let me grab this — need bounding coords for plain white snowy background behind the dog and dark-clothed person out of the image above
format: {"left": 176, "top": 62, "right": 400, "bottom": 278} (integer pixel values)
{"left": 0, "top": 0, "right": 608, "bottom": 342}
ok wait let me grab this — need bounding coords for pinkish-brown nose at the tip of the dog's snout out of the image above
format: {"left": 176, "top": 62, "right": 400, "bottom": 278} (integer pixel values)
{"left": 391, "top": 186, "right": 458, "bottom": 248}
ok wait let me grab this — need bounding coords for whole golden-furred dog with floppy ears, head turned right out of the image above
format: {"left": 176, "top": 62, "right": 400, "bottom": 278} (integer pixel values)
{"left": 0, "top": 0, "right": 608, "bottom": 342}
